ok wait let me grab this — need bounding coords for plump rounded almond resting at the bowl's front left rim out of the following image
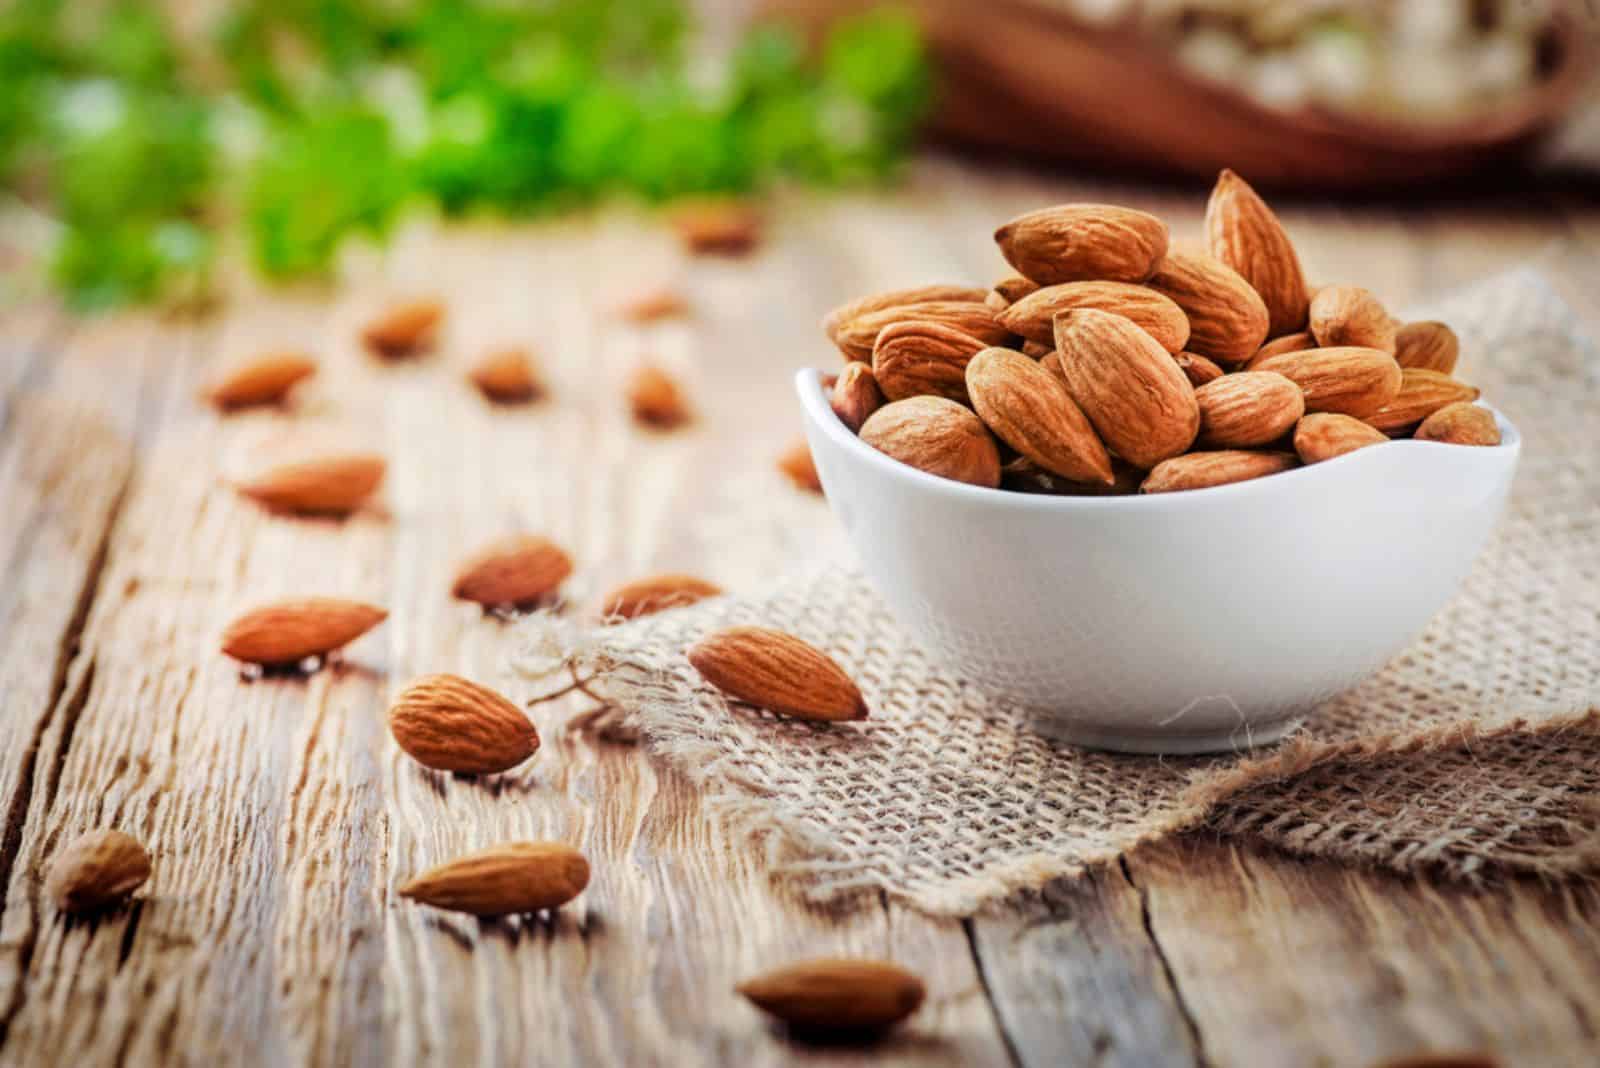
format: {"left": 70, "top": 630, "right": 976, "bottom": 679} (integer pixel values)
{"left": 861, "top": 396, "right": 998, "bottom": 488}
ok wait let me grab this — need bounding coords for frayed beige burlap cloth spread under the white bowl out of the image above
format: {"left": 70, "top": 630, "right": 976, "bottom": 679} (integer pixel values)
{"left": 517, "top": 272, "right": 1600, "bottom": 915}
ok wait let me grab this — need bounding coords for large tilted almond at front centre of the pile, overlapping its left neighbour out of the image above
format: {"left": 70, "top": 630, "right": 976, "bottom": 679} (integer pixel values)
{"left": 1056, "top": 310, "right": 1200, "bottom": 468}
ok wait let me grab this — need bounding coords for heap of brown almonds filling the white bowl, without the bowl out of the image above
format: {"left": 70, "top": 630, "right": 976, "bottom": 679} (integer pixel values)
{"left": 824, "top": 171, "right": 1499, "bottom": 496}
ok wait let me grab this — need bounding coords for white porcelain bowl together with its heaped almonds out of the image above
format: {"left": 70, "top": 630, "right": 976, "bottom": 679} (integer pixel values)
{"left": 797, "top": 171, "right": 1520, "bottom": 753}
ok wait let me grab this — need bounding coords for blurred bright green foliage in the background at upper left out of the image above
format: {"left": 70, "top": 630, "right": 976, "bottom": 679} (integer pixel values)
{"left": 0, "top": 0, "right": 928, "bottom": 305}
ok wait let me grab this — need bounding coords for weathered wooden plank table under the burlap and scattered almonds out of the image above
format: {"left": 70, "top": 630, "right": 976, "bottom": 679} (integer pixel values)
{"left": 0, "top": 160, "right": 1600, "bottom": 1068}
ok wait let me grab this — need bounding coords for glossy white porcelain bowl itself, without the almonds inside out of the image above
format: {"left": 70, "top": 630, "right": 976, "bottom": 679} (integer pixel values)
{"left": 795, "top": 371, "right": 1522, "bottom": 753}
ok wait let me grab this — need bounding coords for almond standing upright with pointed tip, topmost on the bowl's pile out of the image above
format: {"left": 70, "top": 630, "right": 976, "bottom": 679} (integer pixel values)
{"left": 1205, "top": 169, "right": 1309, "bottom": 337}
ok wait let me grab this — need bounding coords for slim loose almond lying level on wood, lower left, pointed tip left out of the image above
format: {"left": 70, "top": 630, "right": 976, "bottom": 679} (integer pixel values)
{"left": 400, "top": 843, "right": 589, "bottom": 916}
